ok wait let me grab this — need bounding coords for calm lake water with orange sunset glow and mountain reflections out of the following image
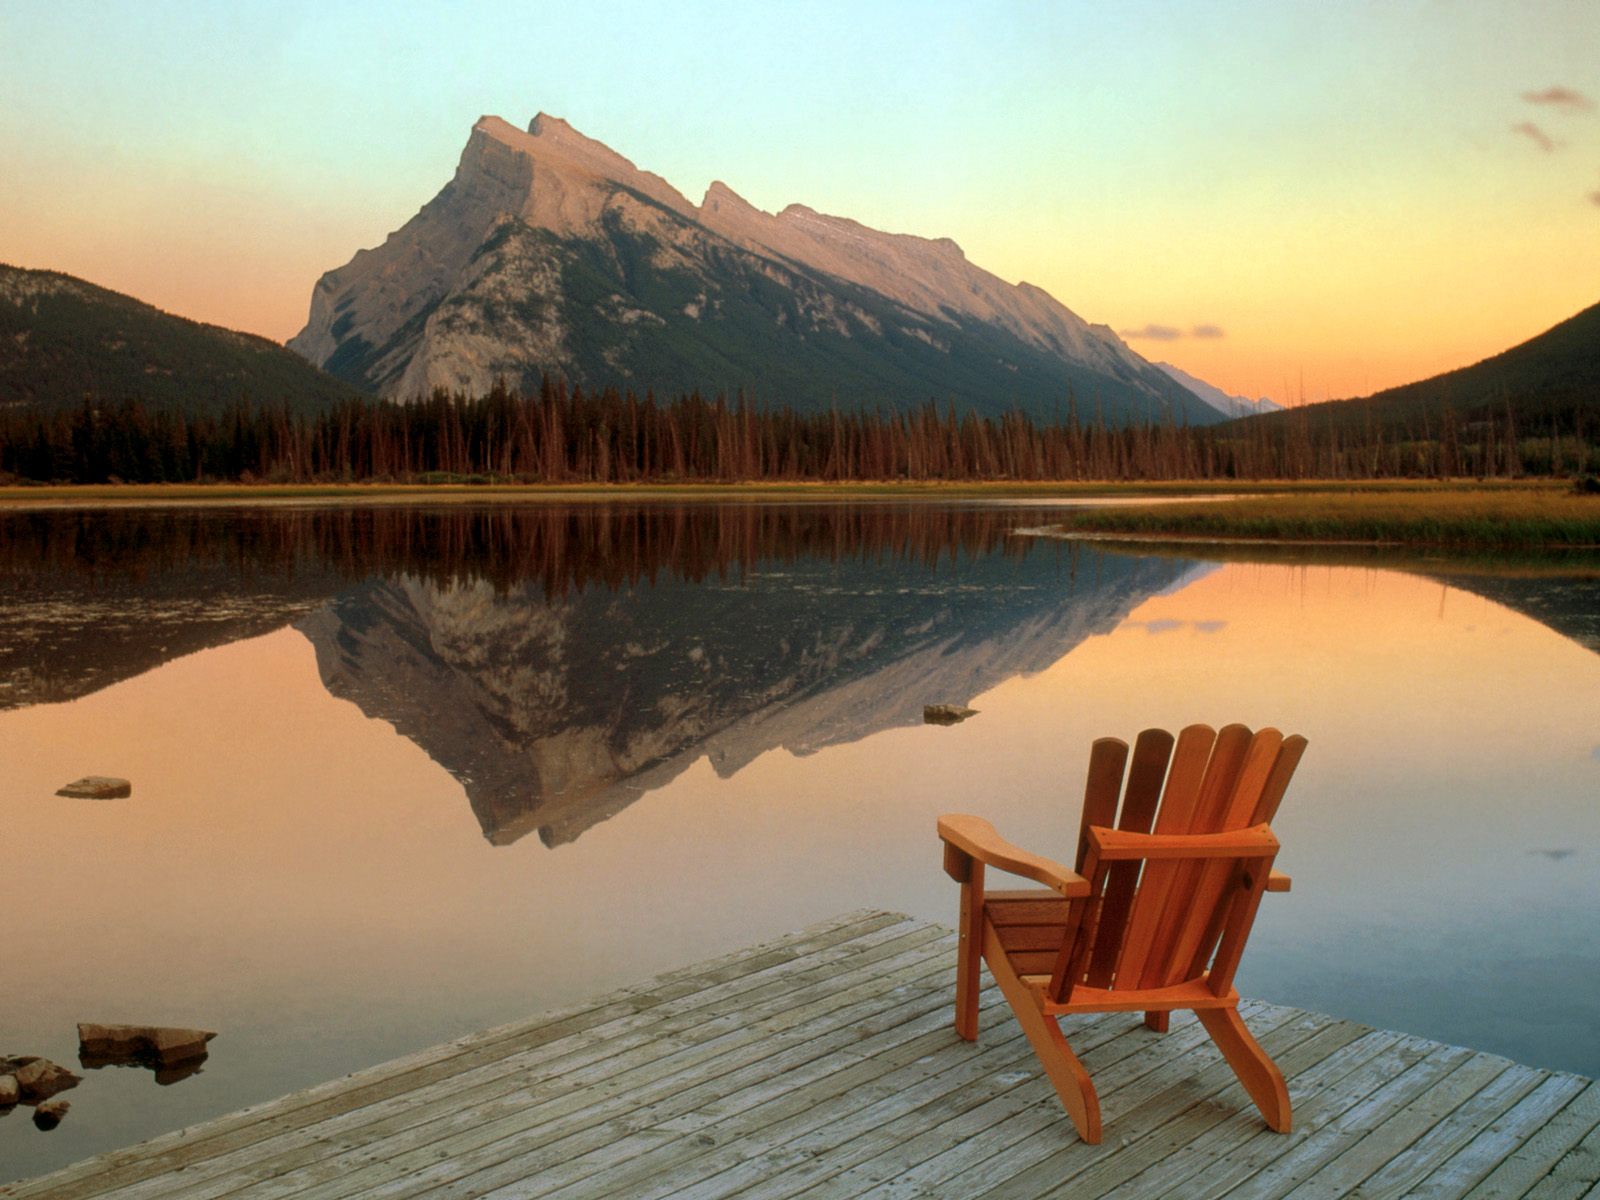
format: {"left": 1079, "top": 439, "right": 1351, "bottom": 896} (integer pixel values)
{"left": 0, "top": 504, "right": 1600, "bottom": 1179}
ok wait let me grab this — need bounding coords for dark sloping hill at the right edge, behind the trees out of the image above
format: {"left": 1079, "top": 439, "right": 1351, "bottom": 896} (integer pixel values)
{"left": 1241, "top": 304, "right": 1600, "bottom": 437}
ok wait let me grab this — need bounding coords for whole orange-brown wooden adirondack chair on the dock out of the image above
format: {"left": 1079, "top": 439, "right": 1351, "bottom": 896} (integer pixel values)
{"left": 939, "top": 725, "right": 1306, "bottom": 1144}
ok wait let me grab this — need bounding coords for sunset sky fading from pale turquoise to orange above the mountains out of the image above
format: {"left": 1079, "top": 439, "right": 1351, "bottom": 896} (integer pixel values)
{"left": 0, "top": 0, "right": 1600, "bottom": 403}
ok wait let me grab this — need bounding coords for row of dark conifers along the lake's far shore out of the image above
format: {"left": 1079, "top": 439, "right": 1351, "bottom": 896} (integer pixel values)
{"left": 0, "top": 376, "right": 1600, "bottom": 483}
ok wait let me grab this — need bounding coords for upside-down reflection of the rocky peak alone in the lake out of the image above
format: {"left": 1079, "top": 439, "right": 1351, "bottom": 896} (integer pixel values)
{"left": 298, "top": 547, "right": 1182, "bottom": 846}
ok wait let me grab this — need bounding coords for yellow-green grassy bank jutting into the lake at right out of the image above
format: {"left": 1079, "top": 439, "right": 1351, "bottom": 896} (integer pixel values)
{"left": 1036, "top": 482, "right": 1600, "bottom": 550}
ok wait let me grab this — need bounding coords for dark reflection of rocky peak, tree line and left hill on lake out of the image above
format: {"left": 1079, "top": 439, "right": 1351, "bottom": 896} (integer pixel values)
{"left": 0, "top": 504, "right": 1192, "bottom": 845}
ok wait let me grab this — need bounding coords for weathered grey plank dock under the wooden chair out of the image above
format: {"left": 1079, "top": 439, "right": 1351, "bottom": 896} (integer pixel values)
{"left": 0, "top": 912, "right": 1600, "bottom": 1200}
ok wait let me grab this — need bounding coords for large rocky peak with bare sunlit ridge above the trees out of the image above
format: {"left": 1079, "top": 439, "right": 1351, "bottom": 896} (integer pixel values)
{"left": 290, "top": 114, "right": 1216, "bottom": 424}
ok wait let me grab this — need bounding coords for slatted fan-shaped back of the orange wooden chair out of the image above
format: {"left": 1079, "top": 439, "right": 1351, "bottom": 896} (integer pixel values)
{"left": 1048, "top": 725, "right": 1306, "bottom": 1003}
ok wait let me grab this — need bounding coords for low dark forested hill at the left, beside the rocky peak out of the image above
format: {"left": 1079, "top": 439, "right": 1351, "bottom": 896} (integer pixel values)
{"left": 0, "top": 264, "right": 360, "bottom": 411}
